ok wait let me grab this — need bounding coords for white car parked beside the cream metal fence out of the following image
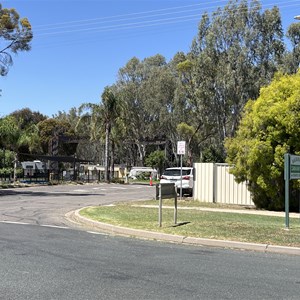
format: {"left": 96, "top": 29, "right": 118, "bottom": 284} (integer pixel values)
{"left": 160, "top": 167, "right": 194, "bottom": 195}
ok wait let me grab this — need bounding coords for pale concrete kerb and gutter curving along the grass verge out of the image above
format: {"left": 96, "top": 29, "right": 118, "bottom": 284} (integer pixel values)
{"left": 65, "top": 208, "right": 300, "bottom": 255}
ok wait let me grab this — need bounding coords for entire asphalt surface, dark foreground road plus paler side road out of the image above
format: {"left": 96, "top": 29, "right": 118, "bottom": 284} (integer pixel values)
{"left": 0, "top": 184, "right": 300, "bottom": 300}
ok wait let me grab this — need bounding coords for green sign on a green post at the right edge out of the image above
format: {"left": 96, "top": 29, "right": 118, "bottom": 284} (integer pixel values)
{"left": 284, "top": 153, "right": 300, "bottom": 229}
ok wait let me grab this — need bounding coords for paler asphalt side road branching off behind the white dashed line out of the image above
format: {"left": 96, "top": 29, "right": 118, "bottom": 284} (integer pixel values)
{"left": 0, "top": 183, "right": 155, "bottom": 226}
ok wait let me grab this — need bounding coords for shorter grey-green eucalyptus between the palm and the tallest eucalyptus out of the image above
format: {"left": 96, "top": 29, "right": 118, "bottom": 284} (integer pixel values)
{"left": 116, "top": 54, "right": 176, "bottom": 165}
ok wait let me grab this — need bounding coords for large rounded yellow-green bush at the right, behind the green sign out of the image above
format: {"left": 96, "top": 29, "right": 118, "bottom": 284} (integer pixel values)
{"left": 225, "top": 72, "right": 300, "bottom": 210}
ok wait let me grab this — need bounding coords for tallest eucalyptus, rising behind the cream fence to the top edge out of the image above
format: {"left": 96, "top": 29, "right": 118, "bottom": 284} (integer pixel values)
{"left": 182, "top": 0, "right": 285, "bottom": 162}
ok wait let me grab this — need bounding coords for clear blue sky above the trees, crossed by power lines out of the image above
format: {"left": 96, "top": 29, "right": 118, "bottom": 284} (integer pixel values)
{"left": 0, "top": 0, "right": 300, "bottom": 117}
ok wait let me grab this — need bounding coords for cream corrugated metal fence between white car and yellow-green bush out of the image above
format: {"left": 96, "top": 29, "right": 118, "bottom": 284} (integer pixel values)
{"left": 194, "top": 163, "right": 254, "bottom": 205}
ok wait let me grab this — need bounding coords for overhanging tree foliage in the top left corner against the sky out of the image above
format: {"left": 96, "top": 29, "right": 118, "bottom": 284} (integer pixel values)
{"left": 0, "top": 4, "right": 33, "bottom": 76}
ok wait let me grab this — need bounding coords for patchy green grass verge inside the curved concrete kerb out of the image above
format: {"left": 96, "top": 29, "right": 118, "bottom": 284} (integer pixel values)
{"left": 80, "top": 201, "right": 300, "bottom": 247}
